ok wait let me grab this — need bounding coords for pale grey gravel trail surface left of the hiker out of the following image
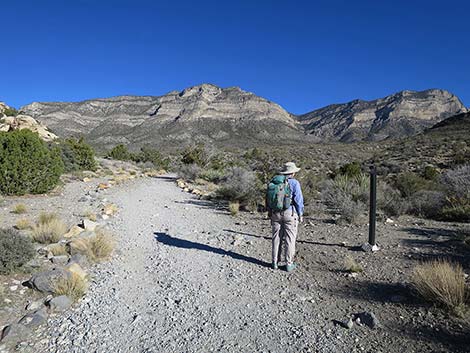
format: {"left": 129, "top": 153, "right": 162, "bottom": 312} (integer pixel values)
{"left": 37, "top": 178, "right": 326, "bottom": 352}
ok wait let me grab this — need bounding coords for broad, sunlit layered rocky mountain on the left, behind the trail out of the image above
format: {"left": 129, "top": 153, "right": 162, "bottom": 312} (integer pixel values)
{"left": 22, "top": 84, "right": 304, "bottom": 147}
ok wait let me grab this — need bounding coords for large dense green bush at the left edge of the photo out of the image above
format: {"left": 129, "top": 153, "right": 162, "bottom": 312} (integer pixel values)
{"left": 0, "top": 129, "right": 64, "bottom": 195}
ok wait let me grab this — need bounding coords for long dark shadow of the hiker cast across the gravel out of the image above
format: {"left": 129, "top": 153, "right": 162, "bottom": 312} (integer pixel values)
{"left": 153, "top": 232, "right": 270, "bottom": 267}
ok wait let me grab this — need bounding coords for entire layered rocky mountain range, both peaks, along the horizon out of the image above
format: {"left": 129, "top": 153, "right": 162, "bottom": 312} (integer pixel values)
{"left": 21, "top": 84, "right": 467, "bottom": 148}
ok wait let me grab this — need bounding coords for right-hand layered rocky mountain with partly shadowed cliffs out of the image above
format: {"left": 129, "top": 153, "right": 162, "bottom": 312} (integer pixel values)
{"left": 298, "top": 89, "right": 467, "bottom": 142}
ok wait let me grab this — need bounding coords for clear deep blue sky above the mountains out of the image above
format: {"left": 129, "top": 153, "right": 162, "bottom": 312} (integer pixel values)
{"left": 0, "top": 0, "right": 470, "bottom": 114}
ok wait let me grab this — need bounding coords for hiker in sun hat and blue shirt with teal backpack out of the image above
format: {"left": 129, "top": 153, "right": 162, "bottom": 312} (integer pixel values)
{"left": 266, "top": 162, "right": 304, "bottom": 272}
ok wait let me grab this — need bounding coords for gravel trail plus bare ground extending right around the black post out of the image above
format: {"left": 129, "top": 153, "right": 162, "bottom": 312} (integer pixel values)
{"left": 25, "top": 177, "right": 468, "bottom": 352}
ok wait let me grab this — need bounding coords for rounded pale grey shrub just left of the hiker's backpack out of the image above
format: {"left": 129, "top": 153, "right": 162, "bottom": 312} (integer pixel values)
{"left": 216, "top": 167, "right": 262, "bottom": 207}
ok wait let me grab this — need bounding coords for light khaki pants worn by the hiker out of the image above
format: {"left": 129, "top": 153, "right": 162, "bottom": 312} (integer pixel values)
{"left": 271, "top": 209, "right": 299, "bottom": 264}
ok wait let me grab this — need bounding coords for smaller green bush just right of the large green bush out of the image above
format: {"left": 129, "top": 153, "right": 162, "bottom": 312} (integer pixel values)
{"left": 59, "top": 138, "right": 97, "bottom": 172}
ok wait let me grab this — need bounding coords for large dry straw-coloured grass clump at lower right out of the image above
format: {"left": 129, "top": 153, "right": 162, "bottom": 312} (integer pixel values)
{"left": 411, "top": 260, "right": 467, "bottom": 309}
